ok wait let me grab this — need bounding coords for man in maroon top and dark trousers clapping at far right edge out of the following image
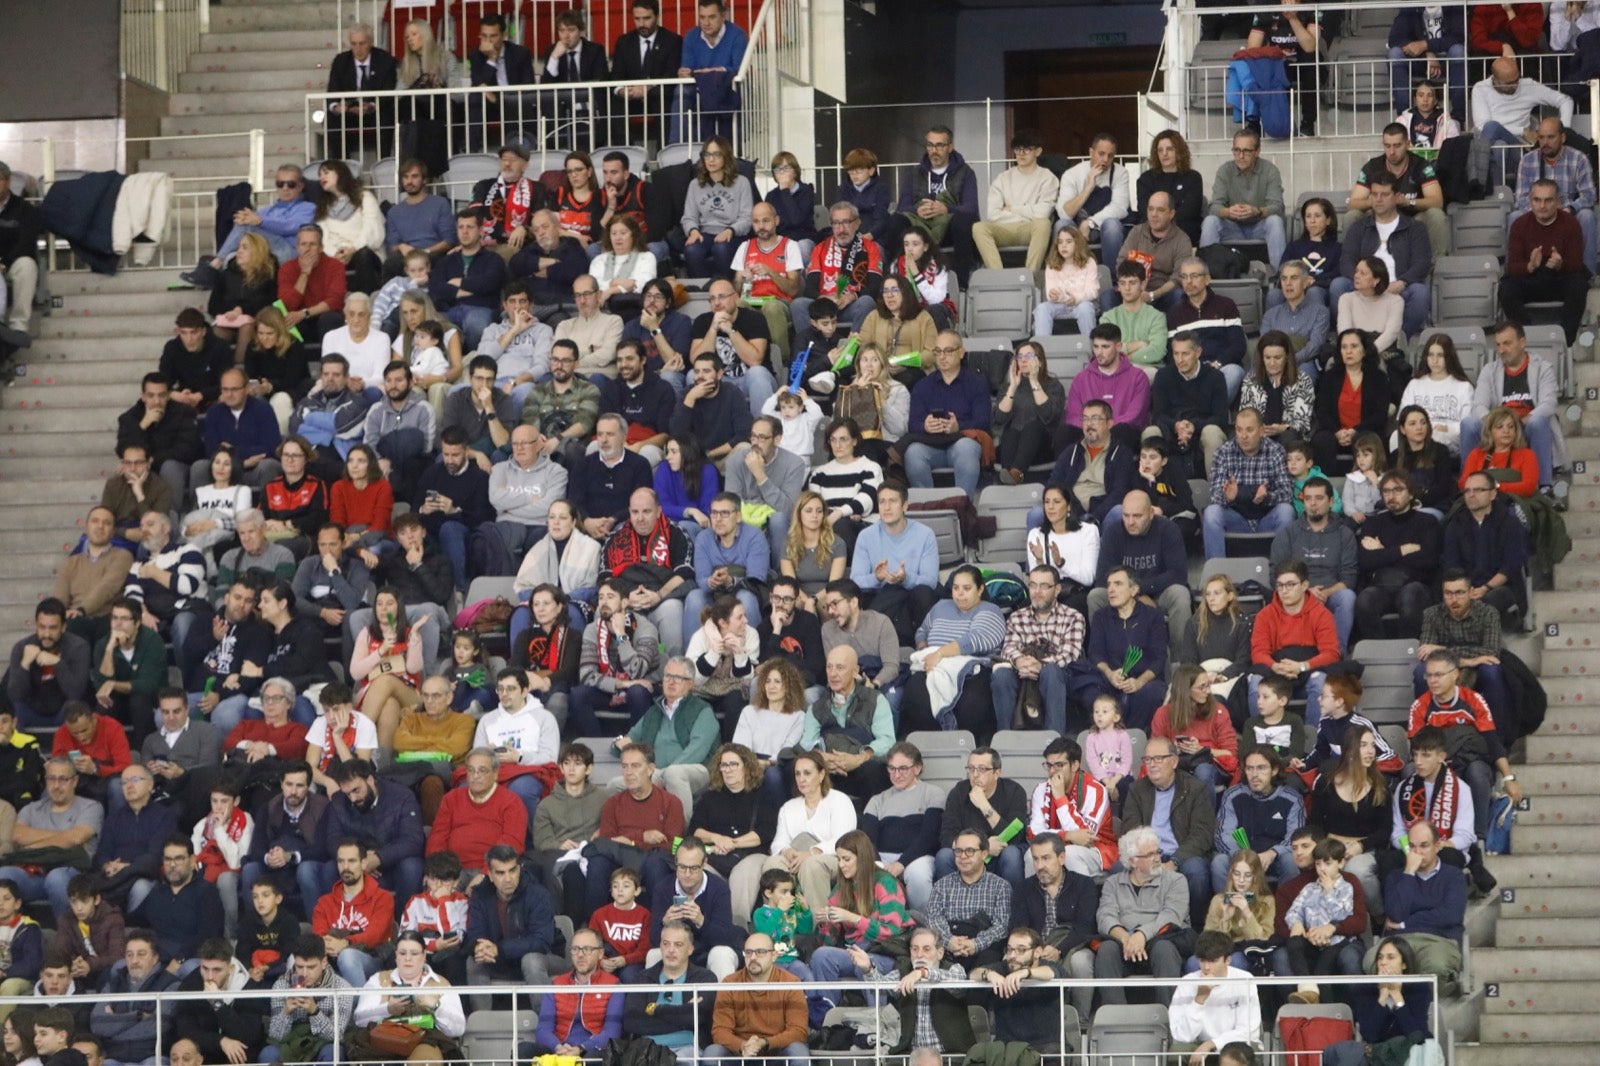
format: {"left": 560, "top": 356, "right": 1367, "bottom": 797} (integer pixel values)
{"left": 1499, "top": 175, "right": 1594, "bottom": 344}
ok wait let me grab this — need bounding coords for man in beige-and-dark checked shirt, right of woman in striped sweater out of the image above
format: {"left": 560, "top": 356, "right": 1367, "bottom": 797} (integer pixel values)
{"left": 989, "top": 563, "right": 1088, "bottom": 733}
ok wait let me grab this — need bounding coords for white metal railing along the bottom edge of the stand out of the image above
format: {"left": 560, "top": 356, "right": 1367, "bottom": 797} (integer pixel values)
{"left": 0, "top": 964, "right": 1450, "bottom": 1066}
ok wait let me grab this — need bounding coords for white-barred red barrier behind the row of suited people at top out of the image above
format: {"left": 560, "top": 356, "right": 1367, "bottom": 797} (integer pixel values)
{"left": 334, "top": 0, "right": 763, "bottom": 68}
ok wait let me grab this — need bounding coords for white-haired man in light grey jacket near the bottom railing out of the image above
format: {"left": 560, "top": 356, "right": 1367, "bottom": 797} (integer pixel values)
{"left": 1094, "top": 819, "right": 1196, "bottom": 1004}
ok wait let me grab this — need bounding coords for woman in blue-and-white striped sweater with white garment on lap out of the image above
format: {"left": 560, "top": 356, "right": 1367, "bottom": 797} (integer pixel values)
{"left": 899, "top": 563, "right": 1005, "bottom": 747}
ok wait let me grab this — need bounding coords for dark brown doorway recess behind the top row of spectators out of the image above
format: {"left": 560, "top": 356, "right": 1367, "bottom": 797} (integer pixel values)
{"left": 1005, "top": 46, "right": 1157, "bottom": 158}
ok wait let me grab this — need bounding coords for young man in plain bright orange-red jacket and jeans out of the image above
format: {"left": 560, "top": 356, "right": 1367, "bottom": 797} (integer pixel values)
{"left": 1250, "top": 559, "right": 1339, "bottom": 728}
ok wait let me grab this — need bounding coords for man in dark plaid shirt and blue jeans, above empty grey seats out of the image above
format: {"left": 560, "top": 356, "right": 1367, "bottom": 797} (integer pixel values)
{"left": 1200, "top": 407, "right": 1299, "bottom": 560}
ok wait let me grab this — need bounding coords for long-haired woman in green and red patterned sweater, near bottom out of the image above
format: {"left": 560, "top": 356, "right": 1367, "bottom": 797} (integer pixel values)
{"left": 811, "top": 829, "right": 917, "bottom": 997}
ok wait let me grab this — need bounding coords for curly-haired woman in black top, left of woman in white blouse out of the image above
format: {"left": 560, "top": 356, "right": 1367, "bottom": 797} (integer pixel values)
{"left": 683, "top": 739, "right": 780, "bottom": 924}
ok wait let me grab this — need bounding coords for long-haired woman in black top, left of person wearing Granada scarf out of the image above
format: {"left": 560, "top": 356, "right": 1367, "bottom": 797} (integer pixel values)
{"left": 1306, "top": 723, "right": 1394, "bottom": 912}
